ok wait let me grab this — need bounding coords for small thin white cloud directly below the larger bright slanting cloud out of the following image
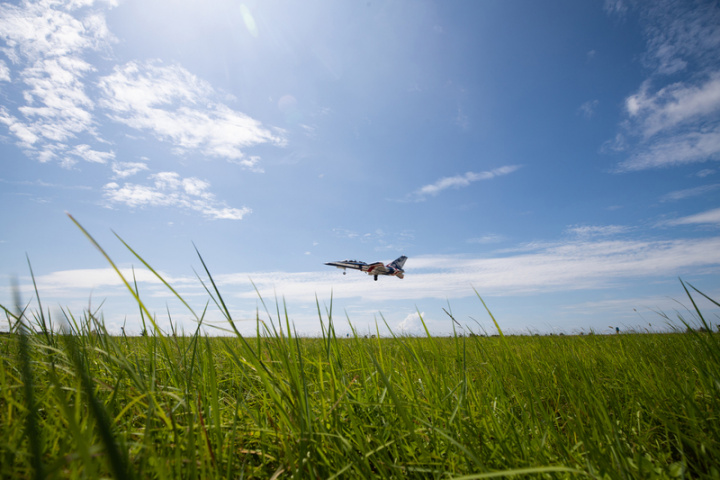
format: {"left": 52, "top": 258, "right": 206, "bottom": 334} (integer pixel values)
{"left": 104, "top": 172, "right": 252, "bottom": 220}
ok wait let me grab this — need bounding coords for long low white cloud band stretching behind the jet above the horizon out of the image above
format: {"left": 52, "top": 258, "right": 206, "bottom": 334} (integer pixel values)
{"left": 7, "top": 234, "right": 720, "bottom": 328}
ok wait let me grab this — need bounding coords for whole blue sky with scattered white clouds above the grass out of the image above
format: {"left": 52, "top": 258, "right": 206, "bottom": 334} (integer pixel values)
{"left": 0, "top": 0, "right": 720, "bottom": 335}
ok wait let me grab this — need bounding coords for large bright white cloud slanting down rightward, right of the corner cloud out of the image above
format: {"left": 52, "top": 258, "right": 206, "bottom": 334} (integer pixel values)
{"left": 99, "top": 62, "right": 285, "bottom": 169}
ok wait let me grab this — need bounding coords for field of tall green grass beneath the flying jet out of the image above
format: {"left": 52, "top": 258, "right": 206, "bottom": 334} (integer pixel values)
{"left": 0, "top": 219, "right": 720, "bottom": 479}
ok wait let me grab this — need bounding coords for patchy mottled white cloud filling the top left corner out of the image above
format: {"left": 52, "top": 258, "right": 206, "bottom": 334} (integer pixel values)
{"left": 0, "top": 1, "right": 114, "bottom": 164}
